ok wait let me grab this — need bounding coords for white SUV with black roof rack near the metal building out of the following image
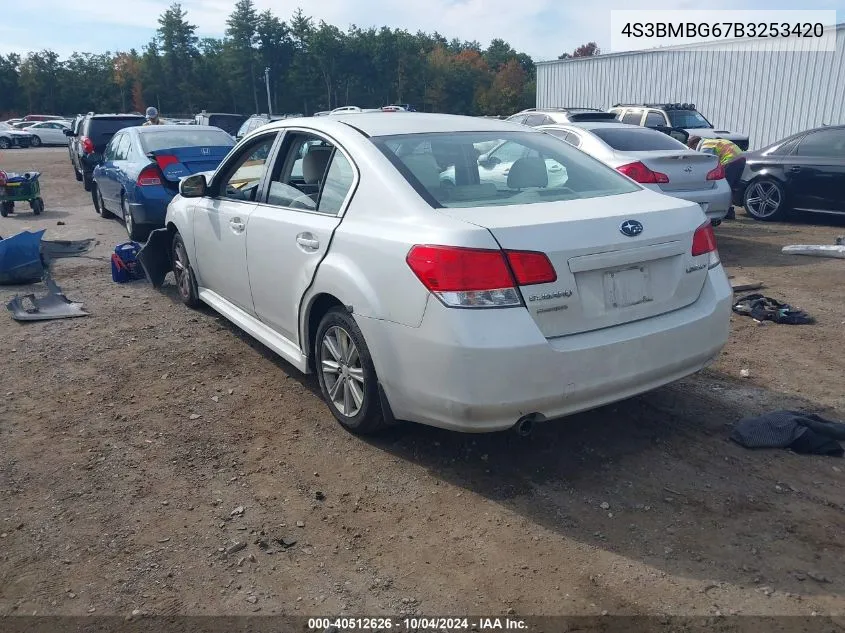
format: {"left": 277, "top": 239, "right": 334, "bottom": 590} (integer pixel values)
{"left": 610, "top": 103, "right": 748, "bottom": 151}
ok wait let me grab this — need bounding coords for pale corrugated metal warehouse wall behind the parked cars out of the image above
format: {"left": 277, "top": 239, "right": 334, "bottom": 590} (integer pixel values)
{"left": 537, "top": 25, "right": 845, "bottom": 149}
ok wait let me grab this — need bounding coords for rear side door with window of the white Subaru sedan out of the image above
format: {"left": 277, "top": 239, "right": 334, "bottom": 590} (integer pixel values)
{"left": 247, "top": 132, "right": 357, "bottom": 344}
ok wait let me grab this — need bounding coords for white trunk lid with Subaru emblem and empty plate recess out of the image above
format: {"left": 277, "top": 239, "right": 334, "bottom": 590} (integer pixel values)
{"left": 438, "top": 191, "right": 709, "bottom": 338}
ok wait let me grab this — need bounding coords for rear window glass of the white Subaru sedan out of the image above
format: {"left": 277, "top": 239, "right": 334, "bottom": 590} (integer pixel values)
{"left": 371, "top": 132, "right": 638, "bottom": 208}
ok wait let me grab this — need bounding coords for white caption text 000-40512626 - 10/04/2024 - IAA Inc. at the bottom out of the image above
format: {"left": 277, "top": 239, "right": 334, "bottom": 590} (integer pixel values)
{"left": 308, "top": 617, "right": 528, "bottom": 633}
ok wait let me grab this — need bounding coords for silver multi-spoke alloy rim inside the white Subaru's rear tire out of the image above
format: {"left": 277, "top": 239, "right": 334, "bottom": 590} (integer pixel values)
{"left": 320, "top": 325, "right": 366, "bottom": 418}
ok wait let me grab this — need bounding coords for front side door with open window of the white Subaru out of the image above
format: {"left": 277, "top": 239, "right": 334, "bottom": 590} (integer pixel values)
{"left": 193, "top": 132, "right": 278, "bottom": 314}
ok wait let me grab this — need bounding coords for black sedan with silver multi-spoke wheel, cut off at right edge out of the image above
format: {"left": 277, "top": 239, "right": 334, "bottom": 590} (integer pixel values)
{"left": 734, "top": 125, "right": 845, "bottom": 220}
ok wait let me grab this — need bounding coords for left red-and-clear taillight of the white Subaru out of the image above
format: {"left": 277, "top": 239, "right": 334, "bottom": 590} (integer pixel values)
{"left": 406, "top": 245, "right": 557, "bottom": 308}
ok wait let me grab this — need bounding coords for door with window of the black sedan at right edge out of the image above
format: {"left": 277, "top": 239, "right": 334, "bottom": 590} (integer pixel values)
{"left": 784, "top": 128, "right": 845, "bottom": 213}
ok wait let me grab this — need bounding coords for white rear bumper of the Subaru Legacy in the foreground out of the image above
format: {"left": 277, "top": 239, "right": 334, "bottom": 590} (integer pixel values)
{"left": 356, "top": 266, "right": 732, "bottom": 432}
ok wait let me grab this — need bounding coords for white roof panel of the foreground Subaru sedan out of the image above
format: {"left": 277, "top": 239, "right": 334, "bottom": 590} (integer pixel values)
{"left": 272, "top": 112, "right": 532, "bottom": 136}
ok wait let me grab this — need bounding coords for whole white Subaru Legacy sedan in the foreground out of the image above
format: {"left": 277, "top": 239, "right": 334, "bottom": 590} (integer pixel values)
{"left": 141, "top": 112, "right": 731, "bottom": 433}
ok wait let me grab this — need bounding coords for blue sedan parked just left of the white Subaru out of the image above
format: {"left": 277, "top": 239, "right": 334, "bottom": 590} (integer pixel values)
{"left": 91, "top": 125, "right": 235, "bottom": 241}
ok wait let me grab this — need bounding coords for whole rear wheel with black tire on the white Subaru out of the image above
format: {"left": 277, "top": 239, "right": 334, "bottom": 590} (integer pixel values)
{"left": 314, "top": 308, "right": 387, "bottom": 435}
